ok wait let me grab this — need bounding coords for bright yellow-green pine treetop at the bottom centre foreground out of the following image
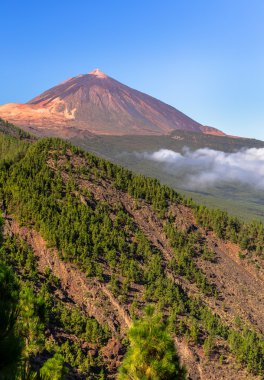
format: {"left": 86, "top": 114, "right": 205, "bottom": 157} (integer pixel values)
{"left": 117, "top": 307, "right": 186, "bottom": 380}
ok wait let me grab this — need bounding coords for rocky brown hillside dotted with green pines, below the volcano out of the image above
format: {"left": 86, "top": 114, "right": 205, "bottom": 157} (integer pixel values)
{"left": 0, "top": 123, "right": 264, "bottom": 379}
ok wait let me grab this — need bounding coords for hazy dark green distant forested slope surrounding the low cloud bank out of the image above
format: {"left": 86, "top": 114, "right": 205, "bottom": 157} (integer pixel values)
{"left": 72, "top": 131, "right": 264, "bottom": 221}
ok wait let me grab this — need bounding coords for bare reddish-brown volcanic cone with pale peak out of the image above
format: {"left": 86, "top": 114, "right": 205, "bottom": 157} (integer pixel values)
{"left": 0, "top": 69, "right": 224, "bottom": 137}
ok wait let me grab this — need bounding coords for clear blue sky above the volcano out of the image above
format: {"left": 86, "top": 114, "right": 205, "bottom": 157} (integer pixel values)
{"left": 0, "top": 0, "right": 264, "bottom": 140}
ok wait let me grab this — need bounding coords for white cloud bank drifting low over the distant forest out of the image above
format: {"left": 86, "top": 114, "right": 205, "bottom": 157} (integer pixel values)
{"left": 136, "top": 148, "right": 264, "bottom": 190}
